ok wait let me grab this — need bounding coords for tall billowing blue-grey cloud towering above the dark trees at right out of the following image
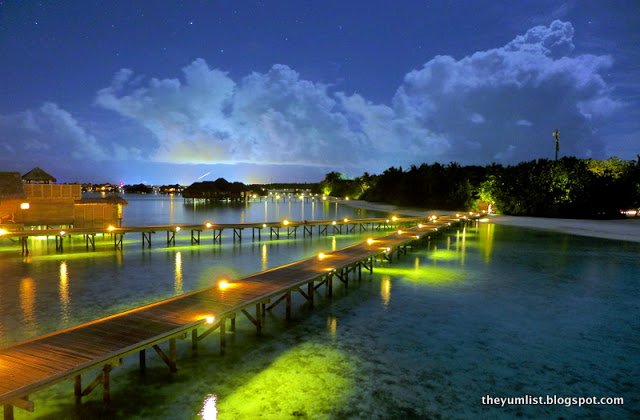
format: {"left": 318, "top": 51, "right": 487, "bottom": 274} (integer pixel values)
{"left": 393, "top": 21, "right": 619, "bottom": 163}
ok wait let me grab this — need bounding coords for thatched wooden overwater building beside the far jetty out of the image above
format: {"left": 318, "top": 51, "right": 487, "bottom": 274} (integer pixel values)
{"left": 0, "top": 168, "right": 127, "bottom": 228}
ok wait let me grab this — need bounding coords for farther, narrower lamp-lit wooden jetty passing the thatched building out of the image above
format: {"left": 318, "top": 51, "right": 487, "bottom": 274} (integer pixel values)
{"left": 0, "top": 216, "right": 424, "bottom": 255}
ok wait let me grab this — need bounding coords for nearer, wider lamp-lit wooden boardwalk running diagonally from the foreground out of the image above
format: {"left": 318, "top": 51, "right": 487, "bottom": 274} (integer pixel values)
{"left": 0, "top": 216, "right": 474, "bottom": 420}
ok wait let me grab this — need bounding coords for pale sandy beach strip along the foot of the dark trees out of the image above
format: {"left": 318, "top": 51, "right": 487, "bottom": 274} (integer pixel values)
{"left": 339, "top": 200, "right": 640, "bottom": 242}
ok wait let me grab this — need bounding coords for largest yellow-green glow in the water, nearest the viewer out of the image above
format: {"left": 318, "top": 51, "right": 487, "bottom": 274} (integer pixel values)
{"left": 215, "top": 343, "right": 354, "bottom": 419}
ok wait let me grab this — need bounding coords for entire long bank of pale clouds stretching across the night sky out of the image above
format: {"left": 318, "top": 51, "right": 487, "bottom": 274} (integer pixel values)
{"left": 0, "top": 21, "right": 620, "bottom": 179}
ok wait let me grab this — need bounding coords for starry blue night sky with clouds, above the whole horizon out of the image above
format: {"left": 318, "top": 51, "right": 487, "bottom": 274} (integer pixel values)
{"left": 0, "top": 0, "right": 640, "bottom": 184}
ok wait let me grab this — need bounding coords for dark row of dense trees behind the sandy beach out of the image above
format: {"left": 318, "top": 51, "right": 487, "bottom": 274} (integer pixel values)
{"left": 320, "top": 156, "right": 640, "bottom": 218}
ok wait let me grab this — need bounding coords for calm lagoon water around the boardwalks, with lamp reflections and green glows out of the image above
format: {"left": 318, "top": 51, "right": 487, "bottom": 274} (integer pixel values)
{"left": 0, "top": 196, "right": 640, "bottom": 419}
